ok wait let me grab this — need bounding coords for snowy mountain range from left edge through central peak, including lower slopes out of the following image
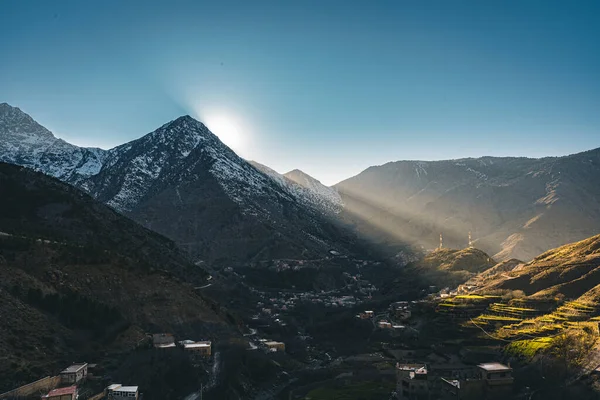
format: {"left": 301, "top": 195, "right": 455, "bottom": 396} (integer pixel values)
{"left": 0, "top": 104, "right": 364, "bottom": 262}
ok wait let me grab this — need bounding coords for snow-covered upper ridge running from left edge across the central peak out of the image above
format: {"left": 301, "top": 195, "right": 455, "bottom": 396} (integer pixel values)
{"left": 0, "top": 103, "right": 341, "bottom": 215}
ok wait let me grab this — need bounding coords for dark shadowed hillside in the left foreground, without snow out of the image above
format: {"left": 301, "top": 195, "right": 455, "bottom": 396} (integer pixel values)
{"left": 0, "top": 163, "right": 235, "bottom": 392}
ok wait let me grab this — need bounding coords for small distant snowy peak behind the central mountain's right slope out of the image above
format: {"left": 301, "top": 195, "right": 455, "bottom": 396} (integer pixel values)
{"left": 250, "top": 161, "right": 343, "bottom": 214}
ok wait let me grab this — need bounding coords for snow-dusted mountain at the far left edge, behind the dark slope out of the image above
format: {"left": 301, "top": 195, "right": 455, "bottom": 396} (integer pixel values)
{"left": 0, "top": 103, "right": 107, "bottom": 184}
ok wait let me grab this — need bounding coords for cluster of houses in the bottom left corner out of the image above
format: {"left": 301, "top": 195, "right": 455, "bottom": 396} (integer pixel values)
{"left": 41, "top": 363, "right": 139, "bottom": 400}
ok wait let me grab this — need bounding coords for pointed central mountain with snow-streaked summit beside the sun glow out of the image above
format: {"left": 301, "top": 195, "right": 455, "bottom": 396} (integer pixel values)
{"left": 81, "top": 116, "right": 350, "bottom": 262}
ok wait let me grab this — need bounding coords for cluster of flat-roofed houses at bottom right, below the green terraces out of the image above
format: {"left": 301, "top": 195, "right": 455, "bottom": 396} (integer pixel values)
{"left": 396, "top": 362, "right": 513, "bottom": 400}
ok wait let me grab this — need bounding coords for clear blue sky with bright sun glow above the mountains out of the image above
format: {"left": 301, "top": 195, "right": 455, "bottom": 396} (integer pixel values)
{"left": 0, "top": 0, "right": 600, "bottom": 184}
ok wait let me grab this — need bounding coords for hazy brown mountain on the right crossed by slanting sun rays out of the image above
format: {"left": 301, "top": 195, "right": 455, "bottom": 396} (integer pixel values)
{"left": 335, "top": 149, "right": 600, "bottom": 260}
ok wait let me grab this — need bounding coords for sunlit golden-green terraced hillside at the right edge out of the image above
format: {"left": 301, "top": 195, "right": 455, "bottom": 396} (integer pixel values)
{"left": 446, "top": 235, "right": 600, "bottom": 354}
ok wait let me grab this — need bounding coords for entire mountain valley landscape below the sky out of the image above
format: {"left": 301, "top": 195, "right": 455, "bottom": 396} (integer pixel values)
{"left": 0, "top": 103, "right": 600, "bottom": 400}
